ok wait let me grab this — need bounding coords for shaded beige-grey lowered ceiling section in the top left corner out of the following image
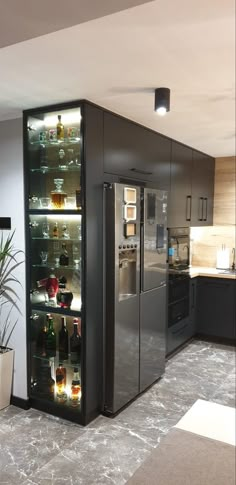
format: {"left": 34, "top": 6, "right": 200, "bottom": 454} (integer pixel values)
{"left": 0, "top": 0, "right": 151, "bottom": 47}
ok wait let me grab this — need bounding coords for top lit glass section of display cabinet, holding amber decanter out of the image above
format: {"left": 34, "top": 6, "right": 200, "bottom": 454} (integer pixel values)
{"left": 27, "top": 108, "right": 81, "bottom": 211}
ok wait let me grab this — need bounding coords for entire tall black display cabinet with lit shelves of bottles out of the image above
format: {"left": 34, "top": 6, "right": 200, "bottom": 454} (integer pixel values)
{"left": 24, "top": 102, "right": 103, "bottom": 424}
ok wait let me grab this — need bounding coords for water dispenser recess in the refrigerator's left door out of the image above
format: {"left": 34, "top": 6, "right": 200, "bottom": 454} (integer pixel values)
{"left": 119, "top": 249, "right": 137, "bottom": 301}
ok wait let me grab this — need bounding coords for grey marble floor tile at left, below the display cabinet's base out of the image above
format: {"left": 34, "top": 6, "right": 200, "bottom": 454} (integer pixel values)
{"left": 0, "top": 409, "right": 85, "bottom": 478}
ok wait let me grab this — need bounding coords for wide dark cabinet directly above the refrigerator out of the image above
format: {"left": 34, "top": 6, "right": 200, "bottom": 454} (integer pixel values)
{"left": 104, "top": 112, "right": 171, "bottom": 190}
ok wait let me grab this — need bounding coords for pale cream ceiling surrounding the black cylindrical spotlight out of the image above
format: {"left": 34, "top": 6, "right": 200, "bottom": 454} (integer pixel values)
{"left": 0, "top": 0, "right": 235, "bottom": 156}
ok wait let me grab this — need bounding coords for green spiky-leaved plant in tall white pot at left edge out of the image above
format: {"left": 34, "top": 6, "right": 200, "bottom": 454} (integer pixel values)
{"left": 0, "top": 232, "right": 23, "bottom": 409}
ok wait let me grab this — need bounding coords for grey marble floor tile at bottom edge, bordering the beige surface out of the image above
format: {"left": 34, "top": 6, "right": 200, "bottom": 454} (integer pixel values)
{"left": 21, "top": 423, "right": 153, "bottom": 485}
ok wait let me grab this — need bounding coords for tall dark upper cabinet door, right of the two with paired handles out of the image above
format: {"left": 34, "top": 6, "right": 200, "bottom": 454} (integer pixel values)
{"left": 191, "top": 150, "right": 215, "bottom": 226}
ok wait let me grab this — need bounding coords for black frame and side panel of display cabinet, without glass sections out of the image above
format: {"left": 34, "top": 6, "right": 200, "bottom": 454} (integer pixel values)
{"left": 23, "top": 100, "right": 103, "bottom": 425}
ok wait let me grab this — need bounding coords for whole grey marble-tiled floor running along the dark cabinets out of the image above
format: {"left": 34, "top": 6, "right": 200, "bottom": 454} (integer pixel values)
{"left": 0, "top": 340, "right": 235, "bottom": 485}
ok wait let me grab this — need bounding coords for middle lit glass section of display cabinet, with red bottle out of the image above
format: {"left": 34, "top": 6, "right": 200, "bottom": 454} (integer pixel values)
{"left": 29, "top": 214, "right": 82, "bottom": 311}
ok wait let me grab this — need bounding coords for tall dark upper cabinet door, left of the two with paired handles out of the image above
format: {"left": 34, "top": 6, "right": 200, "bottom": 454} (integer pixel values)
{"left": 168, "top": 141, "right": 192, "bottom": 227}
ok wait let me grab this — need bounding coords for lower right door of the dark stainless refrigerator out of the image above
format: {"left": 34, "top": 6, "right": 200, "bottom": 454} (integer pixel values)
{"left": 140, "top": 286, "right": 166, "bottom": 392}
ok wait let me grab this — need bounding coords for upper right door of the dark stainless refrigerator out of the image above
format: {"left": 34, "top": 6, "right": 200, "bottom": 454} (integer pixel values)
{"left": 141, "top": 188, "right": 167, "bottom": 291}
